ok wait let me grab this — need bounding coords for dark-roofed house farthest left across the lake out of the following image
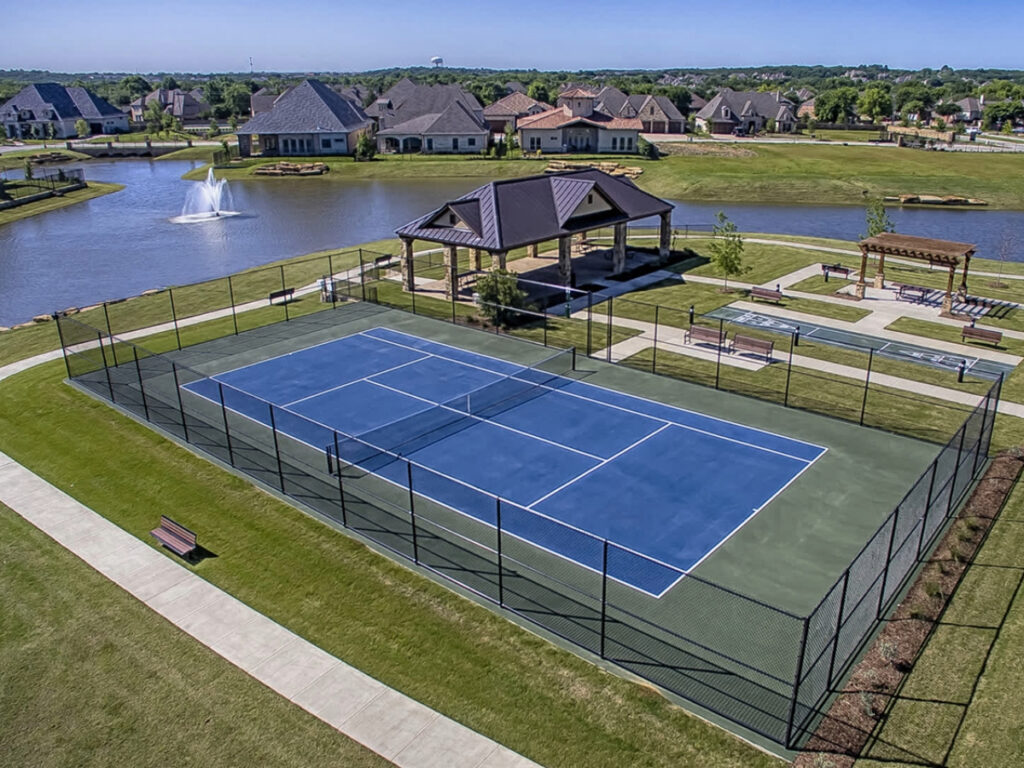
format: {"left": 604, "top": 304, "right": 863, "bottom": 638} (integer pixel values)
{"left": 0, "top": 83, "right": 129, "bottom": 138}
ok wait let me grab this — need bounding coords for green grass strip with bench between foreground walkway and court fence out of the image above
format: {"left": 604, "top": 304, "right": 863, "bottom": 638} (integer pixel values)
{"left": 0, "top": 361, "right": 781, "bottom": 768}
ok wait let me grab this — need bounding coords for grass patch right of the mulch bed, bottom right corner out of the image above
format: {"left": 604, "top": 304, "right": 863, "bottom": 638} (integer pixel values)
{"left": 856, "top": 468, "right": 1024, "bottom": 768}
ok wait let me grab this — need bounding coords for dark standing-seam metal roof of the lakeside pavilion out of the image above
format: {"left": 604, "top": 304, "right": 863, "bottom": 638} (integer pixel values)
{"left": 395, "top": 169, "right": 672, "bottom": 251}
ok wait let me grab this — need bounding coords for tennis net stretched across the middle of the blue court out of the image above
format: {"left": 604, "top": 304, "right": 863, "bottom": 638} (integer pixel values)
{"left": 339, "top": 348, "right": 575, "bottom": 464}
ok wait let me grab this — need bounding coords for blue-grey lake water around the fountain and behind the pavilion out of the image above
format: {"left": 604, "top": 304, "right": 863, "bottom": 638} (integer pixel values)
{"left": 0, "top": 160, "right": 1024, "bottom": 326}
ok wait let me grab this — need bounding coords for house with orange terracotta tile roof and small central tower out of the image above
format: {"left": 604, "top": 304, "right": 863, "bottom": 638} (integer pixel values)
{"left": 518, "top": 88, "right": 643, "bottom": 153}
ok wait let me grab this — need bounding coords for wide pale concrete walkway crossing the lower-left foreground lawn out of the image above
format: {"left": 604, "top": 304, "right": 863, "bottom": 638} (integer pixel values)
{"left": 0, "top": 450, "right": 537, "bottom": 768}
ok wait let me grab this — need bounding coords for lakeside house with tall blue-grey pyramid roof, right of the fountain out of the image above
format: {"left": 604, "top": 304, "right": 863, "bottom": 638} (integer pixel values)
{"left": 237, "top": 80, "right": 373, "bottom": 157}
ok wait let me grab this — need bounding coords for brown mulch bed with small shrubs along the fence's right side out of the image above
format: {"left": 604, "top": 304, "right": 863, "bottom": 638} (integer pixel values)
{"left": 794, "top": 451, "right": 1024, "bottom": 768}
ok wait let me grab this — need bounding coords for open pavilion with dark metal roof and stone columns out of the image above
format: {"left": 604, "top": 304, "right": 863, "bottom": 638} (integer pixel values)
{"left": 395, "top": 169, "right": 672, "bottom": 297}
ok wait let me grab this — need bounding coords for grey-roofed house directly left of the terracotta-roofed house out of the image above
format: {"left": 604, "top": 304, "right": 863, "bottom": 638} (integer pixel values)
{"left": 367, "top": 78, "right": 490, "bottom": 154}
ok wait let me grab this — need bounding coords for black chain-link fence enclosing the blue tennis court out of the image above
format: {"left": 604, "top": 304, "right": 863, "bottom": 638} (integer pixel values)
{"left": 49, "top": 243, "right": 999, "bottom": 746}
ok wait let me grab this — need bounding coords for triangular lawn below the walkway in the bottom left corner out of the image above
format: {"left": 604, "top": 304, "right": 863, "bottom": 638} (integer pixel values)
{"left": 0, "top": 505, "right": 390, "bottom": 768}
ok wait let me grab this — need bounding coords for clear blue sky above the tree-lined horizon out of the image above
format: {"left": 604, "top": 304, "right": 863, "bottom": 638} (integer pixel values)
{"left": 8, "top": 0, "right": 1024, "bottom": 73}
